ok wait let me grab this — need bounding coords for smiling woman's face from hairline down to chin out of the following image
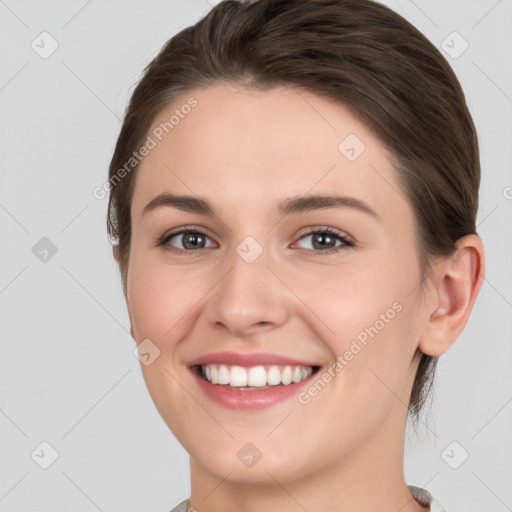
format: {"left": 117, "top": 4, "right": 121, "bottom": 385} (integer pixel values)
{"left": 127, "top": 84, "right": 427, "bottom": 483}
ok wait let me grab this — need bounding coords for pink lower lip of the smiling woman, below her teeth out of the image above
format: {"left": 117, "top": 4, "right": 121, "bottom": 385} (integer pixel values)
{"left": 191, "top": 368, "right": 317, "bottom": 411}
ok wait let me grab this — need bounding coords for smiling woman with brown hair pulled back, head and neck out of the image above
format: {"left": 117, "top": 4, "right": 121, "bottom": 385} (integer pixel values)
{"left": 108, "top": 0, "right": 484, "bottom": 512}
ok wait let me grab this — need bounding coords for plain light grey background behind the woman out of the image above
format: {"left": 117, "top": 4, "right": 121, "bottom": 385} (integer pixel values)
{"left": 0, "top": 0, "right": 512, "bottom": 512}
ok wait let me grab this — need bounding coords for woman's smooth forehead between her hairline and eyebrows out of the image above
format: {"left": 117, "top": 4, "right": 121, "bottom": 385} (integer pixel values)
{"left": 132, "top": 84, "right": 404, "bottom": 218}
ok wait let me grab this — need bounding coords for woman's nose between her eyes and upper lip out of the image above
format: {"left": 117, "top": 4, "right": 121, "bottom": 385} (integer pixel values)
{"left": 203, "top": 242, "right": 291, "bottom": 337}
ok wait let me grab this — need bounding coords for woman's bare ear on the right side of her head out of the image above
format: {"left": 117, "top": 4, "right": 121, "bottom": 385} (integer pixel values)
{"left": 418, "top": 235, "right": 485, "bottom": 356}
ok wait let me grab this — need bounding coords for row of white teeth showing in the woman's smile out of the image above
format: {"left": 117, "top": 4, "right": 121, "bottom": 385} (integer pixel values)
{"left": 201, "top": 364, "right": 313, "bottom": 388}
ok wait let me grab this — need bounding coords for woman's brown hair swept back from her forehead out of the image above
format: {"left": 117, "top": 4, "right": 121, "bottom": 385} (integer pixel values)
{"left": 107, "top": 0, "right": 480, "bottom": 426}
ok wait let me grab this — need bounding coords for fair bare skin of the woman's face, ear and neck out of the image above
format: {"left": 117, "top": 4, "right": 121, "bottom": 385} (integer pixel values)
{"left": 116, "top": 84, "right": 484, "bottom": 512}
